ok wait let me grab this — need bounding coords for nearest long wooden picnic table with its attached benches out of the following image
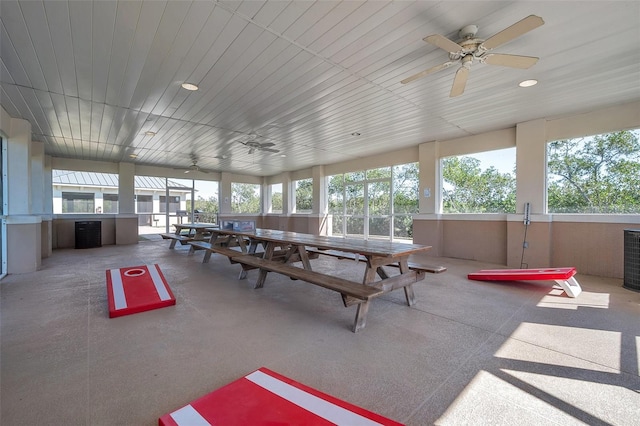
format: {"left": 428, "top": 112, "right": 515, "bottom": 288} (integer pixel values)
{"left": 198, "top": 229, "right": 431, "bottom": 332}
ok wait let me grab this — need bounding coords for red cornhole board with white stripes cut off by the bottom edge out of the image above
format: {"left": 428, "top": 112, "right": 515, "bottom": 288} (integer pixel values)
{"left": 159, "top": 367, "right": 401, "bottom": 426}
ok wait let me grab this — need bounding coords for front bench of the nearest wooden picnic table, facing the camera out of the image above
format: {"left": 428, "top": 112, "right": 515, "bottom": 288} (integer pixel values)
{"left": 231, "top": 255, "right": 385, "bottom": 333}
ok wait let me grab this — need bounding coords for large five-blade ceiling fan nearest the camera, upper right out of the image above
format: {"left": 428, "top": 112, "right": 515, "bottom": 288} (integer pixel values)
{"left": 400, "top": 15, "right": 544, "bottom": 98}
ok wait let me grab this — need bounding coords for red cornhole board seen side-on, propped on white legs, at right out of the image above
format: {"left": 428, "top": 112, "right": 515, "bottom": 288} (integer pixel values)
{"left": 467, "top": 267, "right": 582, "bottom": 297}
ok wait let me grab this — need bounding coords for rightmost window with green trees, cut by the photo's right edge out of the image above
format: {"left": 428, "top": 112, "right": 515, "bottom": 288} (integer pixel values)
{"left": 547, "top": 129, "right": 640, "bottom": 214}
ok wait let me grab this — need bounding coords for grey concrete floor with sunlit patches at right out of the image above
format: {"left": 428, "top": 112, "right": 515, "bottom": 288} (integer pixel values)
{"left": 0, "top": 238, "right": 640, "bottom": 426}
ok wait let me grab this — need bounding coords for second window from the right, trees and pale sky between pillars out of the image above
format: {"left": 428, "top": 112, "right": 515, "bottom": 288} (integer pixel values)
{"left": 441, "top": 148, "right": 516, "bottom": 213}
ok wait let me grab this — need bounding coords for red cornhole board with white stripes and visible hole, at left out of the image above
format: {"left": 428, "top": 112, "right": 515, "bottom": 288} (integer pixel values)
{"left": 107, "top": 264, "right": 176, "bottom": 318}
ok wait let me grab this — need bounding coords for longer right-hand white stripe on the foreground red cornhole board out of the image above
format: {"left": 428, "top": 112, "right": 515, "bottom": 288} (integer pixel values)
{"left": 245, "top": 371, "right": 380, "bottom": 426}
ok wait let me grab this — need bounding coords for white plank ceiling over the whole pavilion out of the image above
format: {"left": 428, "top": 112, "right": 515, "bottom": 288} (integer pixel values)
{"left": 0, "top": 0, "right": 640, "bottom": 176}
